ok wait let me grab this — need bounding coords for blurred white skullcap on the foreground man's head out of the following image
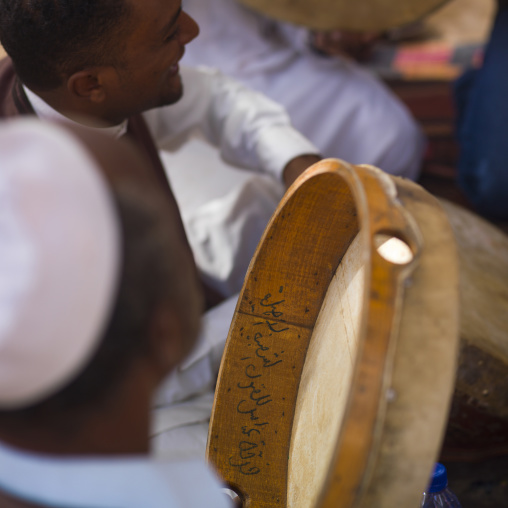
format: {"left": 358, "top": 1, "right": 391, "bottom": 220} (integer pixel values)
{"left": 0, "top": 119, "right": 120, "bottom": 409}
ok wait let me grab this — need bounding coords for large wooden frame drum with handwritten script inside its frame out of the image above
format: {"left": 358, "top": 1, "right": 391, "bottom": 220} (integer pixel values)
{"left": 207, "top": 159, "right": 459, "bottom": 508}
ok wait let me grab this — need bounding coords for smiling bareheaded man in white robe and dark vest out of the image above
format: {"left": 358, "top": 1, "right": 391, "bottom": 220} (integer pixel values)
{"left": 0, "top": 0, "right": 319, "bottom": 456}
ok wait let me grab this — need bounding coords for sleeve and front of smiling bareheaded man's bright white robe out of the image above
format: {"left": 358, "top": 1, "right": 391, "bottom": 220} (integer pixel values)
{"left": 143, "top": 66, "right": 318, "bottom": 296}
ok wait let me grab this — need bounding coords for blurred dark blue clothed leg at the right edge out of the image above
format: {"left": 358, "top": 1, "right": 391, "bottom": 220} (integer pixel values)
{"left": 455, "top": 2, "right": 508, "bottom": 218}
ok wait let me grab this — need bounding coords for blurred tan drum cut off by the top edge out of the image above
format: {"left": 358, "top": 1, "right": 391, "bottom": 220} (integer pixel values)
{"left": 234, "top": 0, "right": 447, "bottom": 32}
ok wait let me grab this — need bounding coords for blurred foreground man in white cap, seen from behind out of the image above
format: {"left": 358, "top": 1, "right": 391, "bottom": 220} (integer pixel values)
{"left": 0, "top": 120, "right": 228, "bottom": 508}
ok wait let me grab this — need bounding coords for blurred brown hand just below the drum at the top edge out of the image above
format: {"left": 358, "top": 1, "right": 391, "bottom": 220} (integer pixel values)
{"left": 311, "top": 30, "right": 382, "bottom": 62}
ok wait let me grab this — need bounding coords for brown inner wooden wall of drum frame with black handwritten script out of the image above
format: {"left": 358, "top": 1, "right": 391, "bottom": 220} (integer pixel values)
{"left": 208, "top": 164, "right": 358, "bottom": 506}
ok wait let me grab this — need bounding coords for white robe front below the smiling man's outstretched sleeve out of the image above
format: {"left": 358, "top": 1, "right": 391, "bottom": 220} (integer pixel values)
{"left": 161, "top": 138, "right": 284, "bottom": 296}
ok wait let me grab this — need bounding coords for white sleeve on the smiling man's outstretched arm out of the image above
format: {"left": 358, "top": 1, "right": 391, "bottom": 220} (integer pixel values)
{"left": 144, "top": 68, "right": 319, "bottom": 178}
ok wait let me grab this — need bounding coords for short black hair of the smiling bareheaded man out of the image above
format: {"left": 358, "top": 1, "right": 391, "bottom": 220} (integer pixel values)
{"left": 0, "top": 0, "right": 131, "bottom": 91}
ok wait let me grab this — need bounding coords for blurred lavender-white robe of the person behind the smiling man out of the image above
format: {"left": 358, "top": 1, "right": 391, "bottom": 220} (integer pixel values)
{"left": 183, "top": 0, "right": 423, "bottom": 179}
